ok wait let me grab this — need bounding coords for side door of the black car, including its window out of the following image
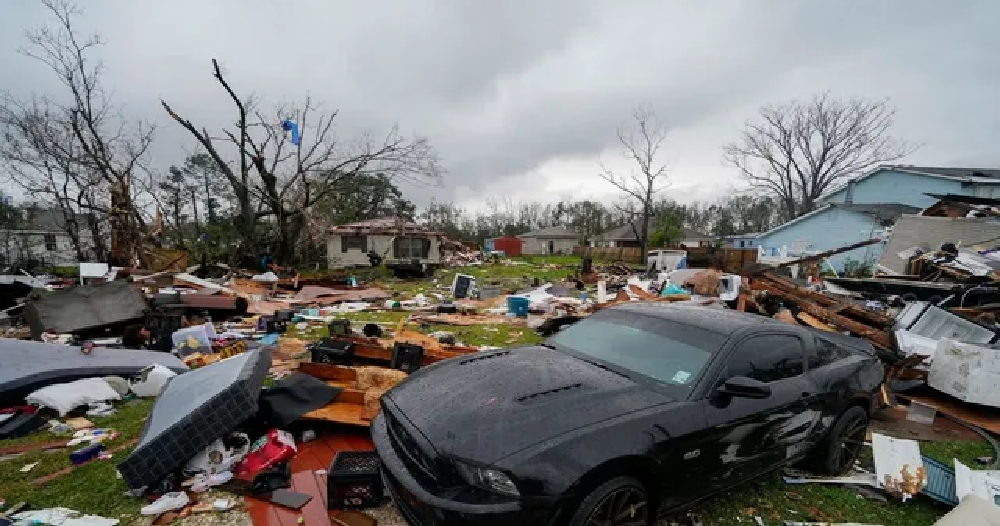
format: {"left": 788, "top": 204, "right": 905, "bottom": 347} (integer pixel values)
{"left": 698, "top": 334, "right": 821, "bottom": 489}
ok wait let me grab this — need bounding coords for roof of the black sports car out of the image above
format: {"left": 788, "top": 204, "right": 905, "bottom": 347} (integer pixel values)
{"left": 609, "top": 301, "right": 790, "bottom": 336}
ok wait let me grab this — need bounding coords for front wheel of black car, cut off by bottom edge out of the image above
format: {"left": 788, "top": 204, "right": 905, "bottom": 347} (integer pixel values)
{"left": 569, "top": 477, "right": 650, "bottom": 526}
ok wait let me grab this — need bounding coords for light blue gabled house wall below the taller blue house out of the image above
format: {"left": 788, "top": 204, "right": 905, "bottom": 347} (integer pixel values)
{"left": 757, "top": 203, "right": 920, "bottom": 272}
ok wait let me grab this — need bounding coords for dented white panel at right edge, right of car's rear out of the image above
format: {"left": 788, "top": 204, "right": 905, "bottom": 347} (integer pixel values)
{"left": 927, "top": 339, "right": 1000, "bottom": 407}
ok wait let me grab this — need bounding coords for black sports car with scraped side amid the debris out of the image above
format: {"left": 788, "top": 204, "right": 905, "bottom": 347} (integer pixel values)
{"left": 372, "top": 303, "right": 883, "bottom": 526}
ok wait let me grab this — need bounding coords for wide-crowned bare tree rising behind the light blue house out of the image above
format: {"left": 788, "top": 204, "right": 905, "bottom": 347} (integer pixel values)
{"left": 723, "top": 93, "right": 916, "bottom": 219}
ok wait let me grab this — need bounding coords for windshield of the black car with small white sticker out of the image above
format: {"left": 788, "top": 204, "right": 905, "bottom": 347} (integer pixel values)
{"left": 548, "top": 311, "right": 726, "bottom": 392}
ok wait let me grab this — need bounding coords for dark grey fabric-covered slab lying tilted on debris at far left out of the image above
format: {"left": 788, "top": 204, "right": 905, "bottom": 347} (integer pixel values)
{"left": 24, "top": 280, "right": 147, "bottom": 338}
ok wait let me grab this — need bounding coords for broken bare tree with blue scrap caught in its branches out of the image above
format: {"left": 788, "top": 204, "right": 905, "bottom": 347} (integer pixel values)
{"left": 162, "top": 59, "right": 442, "bottom": 261}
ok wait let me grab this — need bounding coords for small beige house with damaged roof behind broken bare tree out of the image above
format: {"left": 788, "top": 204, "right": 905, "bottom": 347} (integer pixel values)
{"left": 326, "top": 217, "right": 445, "bottom": 268}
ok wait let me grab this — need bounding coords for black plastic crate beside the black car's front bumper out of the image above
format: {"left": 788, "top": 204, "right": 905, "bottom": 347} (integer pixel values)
{"left": 326, "top": 451, "right": 383, "bottom": 510}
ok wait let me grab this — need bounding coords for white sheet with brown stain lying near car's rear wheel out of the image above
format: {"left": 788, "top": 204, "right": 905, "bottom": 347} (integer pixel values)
{"left": 872, "top": 433, "right": 927, "bottom": 501}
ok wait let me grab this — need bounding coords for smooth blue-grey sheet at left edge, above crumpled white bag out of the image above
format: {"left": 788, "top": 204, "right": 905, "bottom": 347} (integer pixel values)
{"left": 0, "top": 338, "right": 188, "bottom": 405}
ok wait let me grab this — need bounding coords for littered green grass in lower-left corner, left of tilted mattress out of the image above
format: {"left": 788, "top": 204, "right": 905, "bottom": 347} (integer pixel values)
{"left": 0, "top": 400, "right": 153, "bottom": 518}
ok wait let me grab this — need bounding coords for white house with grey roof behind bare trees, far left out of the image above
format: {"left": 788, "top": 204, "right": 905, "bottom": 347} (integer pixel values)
{"left": 0, "top": 207, "right": 93, "bottom": 266}
